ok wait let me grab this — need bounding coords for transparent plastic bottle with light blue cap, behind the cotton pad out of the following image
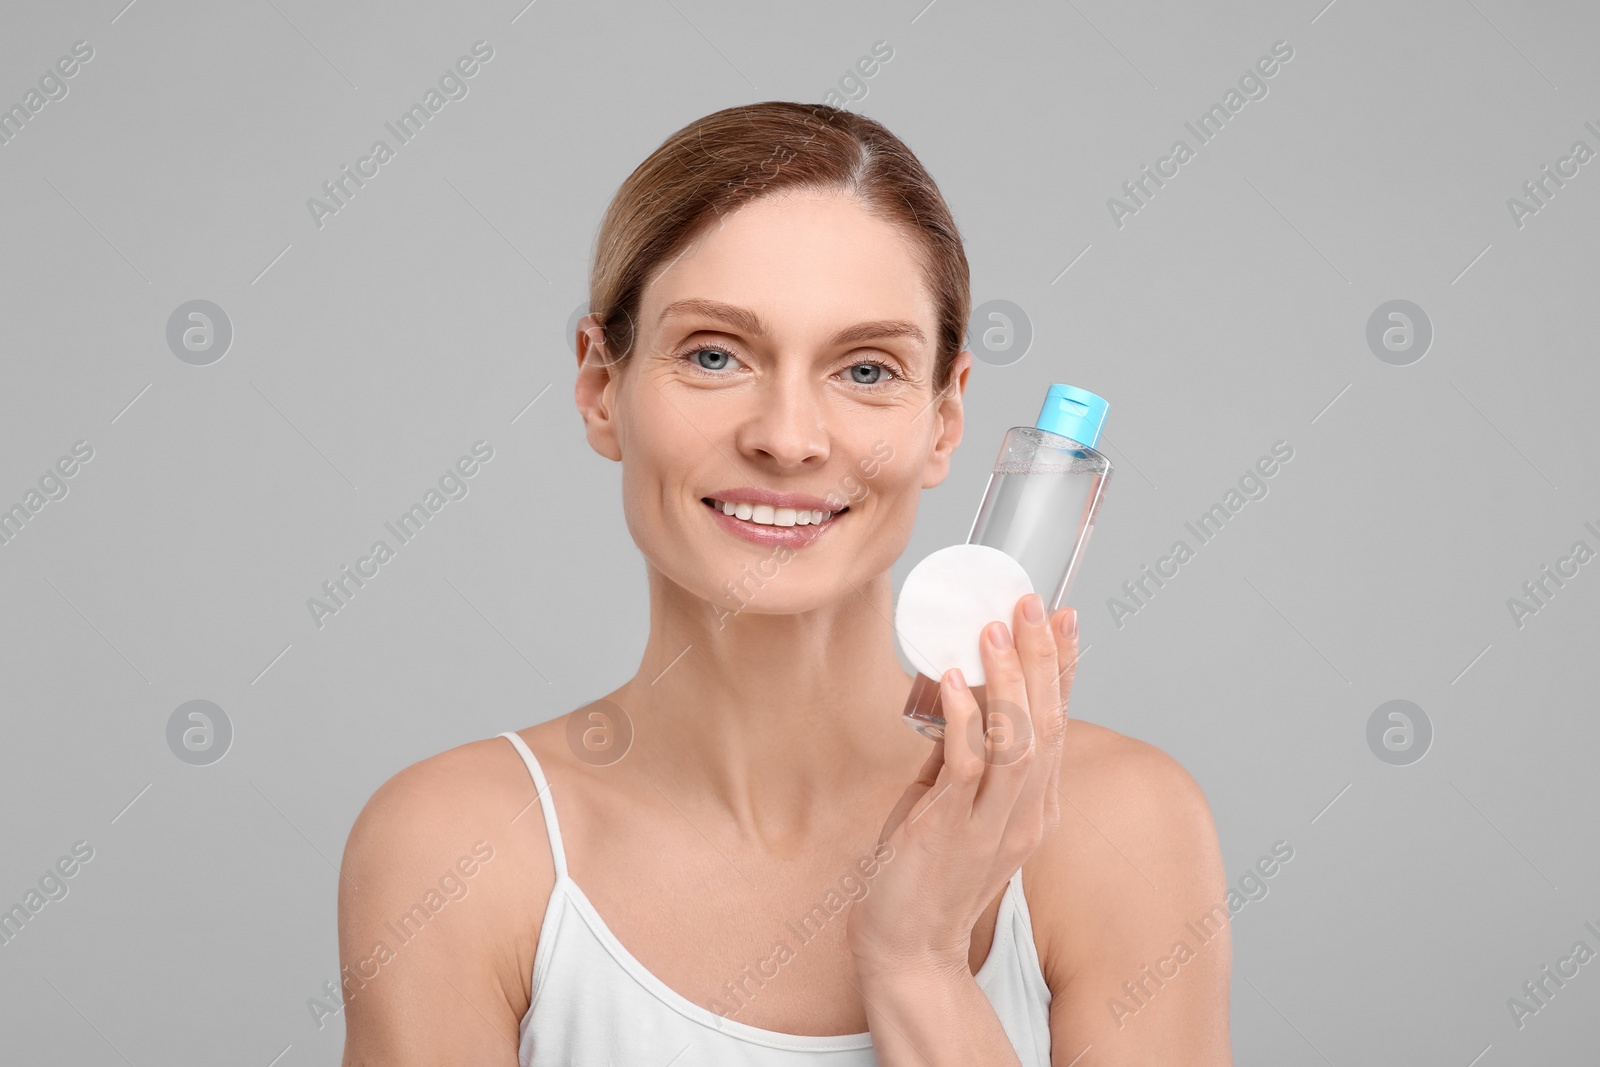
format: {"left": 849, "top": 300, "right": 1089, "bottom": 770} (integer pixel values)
{"left": 902, "top": 384, "right": 1110, "bottom": 739}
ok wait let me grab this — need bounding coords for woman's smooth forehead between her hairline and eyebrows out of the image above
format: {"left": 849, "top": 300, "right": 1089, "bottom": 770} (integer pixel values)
{"left": 640, "top": 192, "right": 934, "bottom": 338}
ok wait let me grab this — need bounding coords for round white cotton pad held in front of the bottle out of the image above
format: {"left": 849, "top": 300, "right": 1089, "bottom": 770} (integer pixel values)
{"left": 894, "top": 544, "right": 1034, "bottom": 685}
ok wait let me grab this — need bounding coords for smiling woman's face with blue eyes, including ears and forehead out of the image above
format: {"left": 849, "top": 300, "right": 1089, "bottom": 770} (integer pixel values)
{"left": 576, "top": 194, "right": 971, "bottom": 619}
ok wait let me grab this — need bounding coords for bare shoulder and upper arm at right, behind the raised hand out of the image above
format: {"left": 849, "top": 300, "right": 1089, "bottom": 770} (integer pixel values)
{"left": 1022, "top": 720, "right": 1232, "bottom": 1067}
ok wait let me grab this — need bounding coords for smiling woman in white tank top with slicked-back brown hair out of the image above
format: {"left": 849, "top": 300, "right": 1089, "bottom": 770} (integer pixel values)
{"left": 339, "top": 102, "right": 1230, "bottom": 1067}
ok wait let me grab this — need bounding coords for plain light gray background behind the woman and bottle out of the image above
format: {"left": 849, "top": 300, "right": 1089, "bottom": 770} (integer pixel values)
{"left": 0, "top": 0, "right": 1600, "bottom": 1067}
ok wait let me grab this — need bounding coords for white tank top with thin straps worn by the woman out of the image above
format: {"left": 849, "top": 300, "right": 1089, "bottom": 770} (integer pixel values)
{"left": 501, "top": 731, "right": 1050, "bottom": 1067}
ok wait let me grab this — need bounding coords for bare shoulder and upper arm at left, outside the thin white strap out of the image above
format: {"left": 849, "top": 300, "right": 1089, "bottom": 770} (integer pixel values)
{"left": 339, "top": 737, "right": 555, "bottom": 1064}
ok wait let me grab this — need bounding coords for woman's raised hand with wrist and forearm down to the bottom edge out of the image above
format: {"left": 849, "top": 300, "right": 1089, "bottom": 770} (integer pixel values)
{"left": 846, "top": 593, "right": 1078, "bottom": 1067}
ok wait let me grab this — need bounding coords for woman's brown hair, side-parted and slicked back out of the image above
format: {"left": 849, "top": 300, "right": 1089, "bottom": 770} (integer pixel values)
{"left": 589, "top": 101, "right": 971, "bottom": 392}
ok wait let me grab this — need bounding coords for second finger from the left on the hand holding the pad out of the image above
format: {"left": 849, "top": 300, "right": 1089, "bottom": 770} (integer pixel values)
{"left": 973, "top": 614, "right": 1035, "bottom": 840}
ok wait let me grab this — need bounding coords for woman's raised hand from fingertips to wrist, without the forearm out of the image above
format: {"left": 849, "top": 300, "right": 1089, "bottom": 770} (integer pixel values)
{"left": 846, "top": 593, "right": 1078, "bottom": 976}
